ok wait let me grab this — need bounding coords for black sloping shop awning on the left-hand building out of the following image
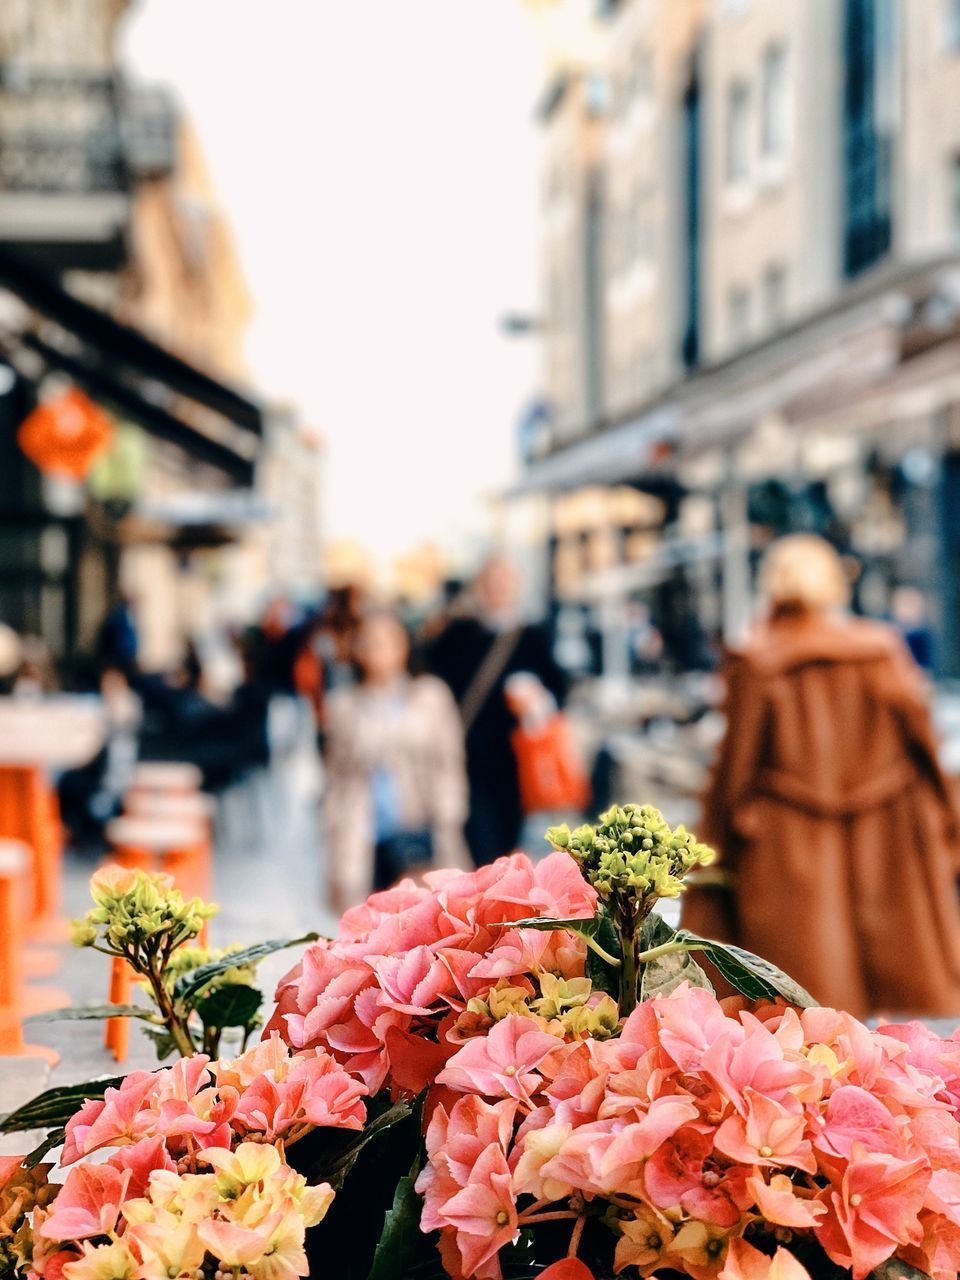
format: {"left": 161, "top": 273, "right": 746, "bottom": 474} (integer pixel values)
{"left": 0, "top": 246, "right": 264, "bottom": 485}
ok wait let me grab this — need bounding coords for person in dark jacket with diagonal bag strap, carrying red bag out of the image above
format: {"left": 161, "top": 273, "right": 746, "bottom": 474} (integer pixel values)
{"left": 425, "top": 557, "right": 567, "bottom": 867}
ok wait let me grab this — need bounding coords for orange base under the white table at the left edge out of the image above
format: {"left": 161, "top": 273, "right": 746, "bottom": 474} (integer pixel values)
{"left": 0, "top": 764, "right": 65, "bottom": 941}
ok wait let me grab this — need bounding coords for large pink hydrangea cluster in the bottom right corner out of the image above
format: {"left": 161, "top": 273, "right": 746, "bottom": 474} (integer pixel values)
{"left": 417, "top": 984, "right": 960, "bottom": 1280}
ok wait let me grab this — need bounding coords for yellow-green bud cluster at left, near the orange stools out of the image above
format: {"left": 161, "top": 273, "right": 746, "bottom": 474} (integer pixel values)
{"left": 73, "top": 867, "right": 218, "bottom": 954}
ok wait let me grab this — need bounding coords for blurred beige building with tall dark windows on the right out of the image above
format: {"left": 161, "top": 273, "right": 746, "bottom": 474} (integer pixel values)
{"left": 525, "top": 0, "right": 960, "bottom": 675}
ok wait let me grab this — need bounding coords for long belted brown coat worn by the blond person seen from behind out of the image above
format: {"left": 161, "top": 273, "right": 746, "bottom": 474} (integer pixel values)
{"left": 684, "top": 616, "right": 960, "bottom": 1016}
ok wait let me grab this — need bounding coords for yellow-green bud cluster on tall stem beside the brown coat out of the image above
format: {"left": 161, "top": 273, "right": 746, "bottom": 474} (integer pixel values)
{"left": 547, "top": 804, "right": 716, "bottom": 910}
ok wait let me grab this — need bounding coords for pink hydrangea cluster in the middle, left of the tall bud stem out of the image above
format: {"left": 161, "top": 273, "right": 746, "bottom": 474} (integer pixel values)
{"left": 268, "top": 852, "right": 601, "bottom": 1093}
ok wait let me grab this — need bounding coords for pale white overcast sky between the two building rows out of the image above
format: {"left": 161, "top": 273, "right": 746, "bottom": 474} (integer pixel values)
{"left": 125, "top": 0, "right": 538, "bottom": 570}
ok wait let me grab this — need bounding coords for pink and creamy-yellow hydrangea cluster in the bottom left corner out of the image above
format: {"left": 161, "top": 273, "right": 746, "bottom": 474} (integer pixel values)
{"left": 6, "top": 1036, "right": 367, "bottom": 1280}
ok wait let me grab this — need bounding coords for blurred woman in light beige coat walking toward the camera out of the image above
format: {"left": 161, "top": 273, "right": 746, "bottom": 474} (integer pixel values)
{"left": 325, "top": 612, "right": 470, "bottom": 910}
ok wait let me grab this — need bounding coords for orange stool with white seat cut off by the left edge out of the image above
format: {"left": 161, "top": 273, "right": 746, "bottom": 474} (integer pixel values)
{"left": 0, "top": 840, "right": 61, "bottom": 1066}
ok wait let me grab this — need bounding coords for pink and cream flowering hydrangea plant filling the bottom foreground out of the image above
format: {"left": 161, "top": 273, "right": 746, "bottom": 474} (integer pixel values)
{"left": 0, "top": 806, "right": 960, "bottom": 1280}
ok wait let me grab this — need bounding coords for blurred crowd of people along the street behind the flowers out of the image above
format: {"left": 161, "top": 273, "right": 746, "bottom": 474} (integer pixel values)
{"left": 0, "top": 535, "right": 960, "bottom": 1015}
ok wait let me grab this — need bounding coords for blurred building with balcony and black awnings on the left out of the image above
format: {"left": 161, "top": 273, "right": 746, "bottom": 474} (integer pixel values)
{"left": 0, "top": 0, "right": 321, "bottom": 664}
